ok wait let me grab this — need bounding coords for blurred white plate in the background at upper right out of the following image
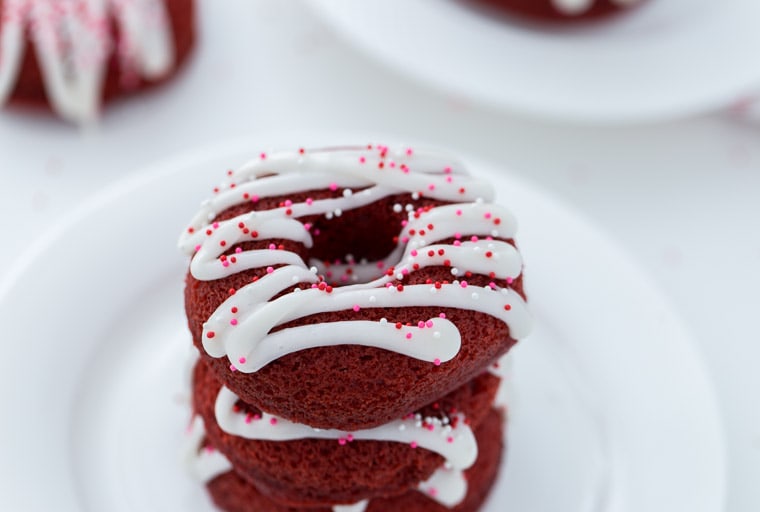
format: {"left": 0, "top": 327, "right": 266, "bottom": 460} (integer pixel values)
{"left": 310, "top": 0, "right": 760, "bottom": 122}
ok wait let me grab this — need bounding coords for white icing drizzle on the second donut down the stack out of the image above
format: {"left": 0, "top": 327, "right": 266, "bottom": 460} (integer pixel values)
{"left": 214, "top": 387, "right": 478, "bottom": 469}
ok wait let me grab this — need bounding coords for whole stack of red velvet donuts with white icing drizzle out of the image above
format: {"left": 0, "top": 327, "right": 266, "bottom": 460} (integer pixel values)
{"left": 180, "top": 145, "right": 531, "bottom": 512}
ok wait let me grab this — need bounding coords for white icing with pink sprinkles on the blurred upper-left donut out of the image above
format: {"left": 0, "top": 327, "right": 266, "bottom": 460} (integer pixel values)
{"left": 0, "top": 0, "right": 175, "bottom": 123}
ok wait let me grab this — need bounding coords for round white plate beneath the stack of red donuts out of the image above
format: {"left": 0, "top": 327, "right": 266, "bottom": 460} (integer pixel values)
{"left": 0, "top": 137, "right": 725, "bottom": 512}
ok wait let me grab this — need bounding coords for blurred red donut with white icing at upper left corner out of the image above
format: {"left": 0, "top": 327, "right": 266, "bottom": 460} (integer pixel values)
{"left": 0, "top": 0, "right": 195, "bottom": 123}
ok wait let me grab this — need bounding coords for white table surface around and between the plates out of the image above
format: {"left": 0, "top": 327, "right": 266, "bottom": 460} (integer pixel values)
{"left": 0, "top": 0, "right": 760, "bottom": 512}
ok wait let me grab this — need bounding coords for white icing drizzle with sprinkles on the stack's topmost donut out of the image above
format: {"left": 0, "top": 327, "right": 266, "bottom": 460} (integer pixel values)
{"left": 179, "top": 145, "right": 531, "bottom": 373}
